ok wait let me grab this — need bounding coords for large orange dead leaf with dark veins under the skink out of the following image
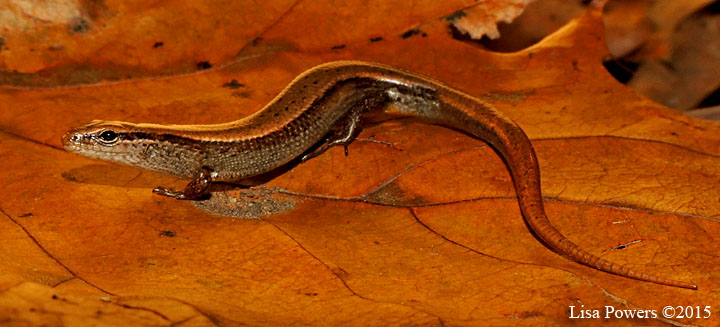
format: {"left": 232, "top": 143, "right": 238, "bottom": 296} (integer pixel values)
{"left": 0, "top": 1, "right": 720, "bottom": 326}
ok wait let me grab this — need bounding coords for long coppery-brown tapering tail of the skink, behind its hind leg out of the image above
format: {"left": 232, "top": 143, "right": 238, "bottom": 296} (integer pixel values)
{"left": 430, "top": 89, "right": 697, "bottom": 290}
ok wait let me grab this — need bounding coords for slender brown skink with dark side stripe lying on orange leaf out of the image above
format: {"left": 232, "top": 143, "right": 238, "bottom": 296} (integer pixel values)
{"left": 62, "top": 61, "right": 697, "bottom": 289}
